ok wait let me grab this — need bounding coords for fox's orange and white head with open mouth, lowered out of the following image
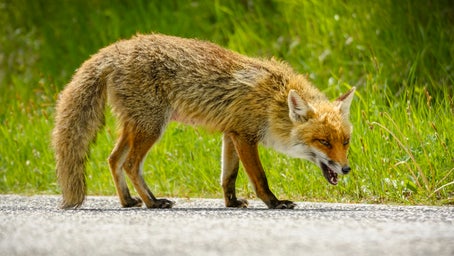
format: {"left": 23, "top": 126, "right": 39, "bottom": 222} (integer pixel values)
{"left": 287, "top": 88, "right": 355, "bottom": 185}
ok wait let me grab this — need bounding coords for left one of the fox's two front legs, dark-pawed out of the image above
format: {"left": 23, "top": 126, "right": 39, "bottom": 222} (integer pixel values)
{"left": 221, "top": 134, "right": 248, "bottom": 208}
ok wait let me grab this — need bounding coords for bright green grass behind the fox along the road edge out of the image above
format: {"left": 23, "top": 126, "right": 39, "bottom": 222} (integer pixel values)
{"left": 0, "top": 0, "right": 454, "bottom": 205}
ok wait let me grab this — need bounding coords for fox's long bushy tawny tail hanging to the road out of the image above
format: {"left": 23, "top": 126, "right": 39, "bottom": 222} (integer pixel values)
{"left": 52, "top": 55, "right": 107, "bottom": 209}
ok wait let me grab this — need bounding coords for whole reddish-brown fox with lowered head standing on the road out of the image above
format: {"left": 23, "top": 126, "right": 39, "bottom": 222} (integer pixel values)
{"left": 52, "top": 33, "right": 355, "bottom": 209}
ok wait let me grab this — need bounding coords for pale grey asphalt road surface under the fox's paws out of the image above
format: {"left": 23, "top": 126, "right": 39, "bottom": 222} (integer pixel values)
{"left": 0, "top": 195, "right": 454, "bottom": 256}
